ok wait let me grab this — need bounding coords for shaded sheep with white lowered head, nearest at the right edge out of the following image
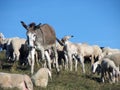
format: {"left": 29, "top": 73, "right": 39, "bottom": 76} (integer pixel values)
{"left": 92, "top": 57, "right": 120, "bottom": 83}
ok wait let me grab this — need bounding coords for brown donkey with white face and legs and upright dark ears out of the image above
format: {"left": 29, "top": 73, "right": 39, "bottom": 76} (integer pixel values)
{"left": 21, "top": 21, "right": 59, "bottom": 74}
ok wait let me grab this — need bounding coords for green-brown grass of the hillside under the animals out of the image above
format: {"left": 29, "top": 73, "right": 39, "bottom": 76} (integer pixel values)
{"left": 0, "top": 52, "right": 120, "bottom": 90}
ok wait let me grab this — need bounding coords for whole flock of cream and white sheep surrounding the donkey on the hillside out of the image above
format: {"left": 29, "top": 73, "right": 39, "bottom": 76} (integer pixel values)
{"left": 0, "top": 27, "right": 120, "bottom": 90}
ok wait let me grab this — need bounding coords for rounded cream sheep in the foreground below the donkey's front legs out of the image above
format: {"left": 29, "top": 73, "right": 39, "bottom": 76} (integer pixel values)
{"left": 31, "top": 68, "right": 52, "bottom": 88}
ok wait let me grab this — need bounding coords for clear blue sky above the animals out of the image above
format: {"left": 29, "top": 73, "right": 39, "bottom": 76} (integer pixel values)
{"left": 0, "top": 0, "right": 120, "bottom": 48}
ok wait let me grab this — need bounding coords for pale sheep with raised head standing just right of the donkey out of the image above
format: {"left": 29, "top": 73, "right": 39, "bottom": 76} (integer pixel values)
{"left": 57, "top": 36, "right": 85, "bottom": 72}
